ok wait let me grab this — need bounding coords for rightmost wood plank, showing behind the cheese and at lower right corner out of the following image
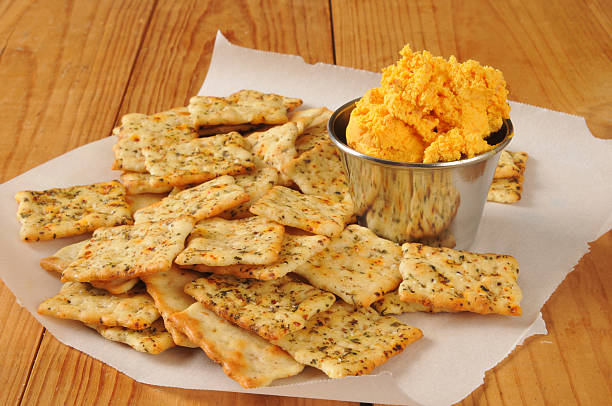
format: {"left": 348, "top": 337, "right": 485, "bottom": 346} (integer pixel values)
{"left": 332, "top": 0, "right": 612, "bottom": 406}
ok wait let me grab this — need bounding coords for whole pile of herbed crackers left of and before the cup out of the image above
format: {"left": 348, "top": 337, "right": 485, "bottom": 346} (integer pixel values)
{"left": 16, "top": 90, "right": 521, "bottom": 388}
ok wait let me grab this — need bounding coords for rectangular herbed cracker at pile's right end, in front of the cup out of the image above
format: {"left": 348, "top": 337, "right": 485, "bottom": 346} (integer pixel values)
{"left": 399, "top": 243, "right": 522, "bottom": 316}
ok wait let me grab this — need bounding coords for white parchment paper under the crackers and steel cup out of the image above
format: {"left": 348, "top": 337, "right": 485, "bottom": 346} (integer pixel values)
{"left": 0, "top": 34, "right": 612, "bottom": 405}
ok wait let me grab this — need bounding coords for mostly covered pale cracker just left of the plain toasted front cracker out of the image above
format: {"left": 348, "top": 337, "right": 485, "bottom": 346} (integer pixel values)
{"left": 142, "top": 266, "right": 202, "bottom": 348}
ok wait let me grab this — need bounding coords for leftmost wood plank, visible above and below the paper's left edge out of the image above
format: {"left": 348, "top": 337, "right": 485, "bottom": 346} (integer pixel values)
{"left": 0, "top": 1, "right": 151, "bottom": 405}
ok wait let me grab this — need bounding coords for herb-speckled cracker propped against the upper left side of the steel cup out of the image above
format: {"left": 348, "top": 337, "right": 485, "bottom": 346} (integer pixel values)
{"left": 283, "top": 141, "right": 353, "bottom": 206}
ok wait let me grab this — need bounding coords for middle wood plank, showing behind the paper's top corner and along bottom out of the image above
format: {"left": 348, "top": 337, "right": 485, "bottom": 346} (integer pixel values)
{"left": 23, "top": 0, "right": 355, "bottom": 406}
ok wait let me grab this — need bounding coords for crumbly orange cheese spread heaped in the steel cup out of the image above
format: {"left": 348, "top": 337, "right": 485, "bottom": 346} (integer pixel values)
{"left": 346, "top": 45, "right": 510, "bottom": 163}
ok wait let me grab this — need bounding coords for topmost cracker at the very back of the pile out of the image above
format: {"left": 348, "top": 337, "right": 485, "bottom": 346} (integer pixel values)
{"left": 188, "top": 90, "right": 302, "bottom": 128}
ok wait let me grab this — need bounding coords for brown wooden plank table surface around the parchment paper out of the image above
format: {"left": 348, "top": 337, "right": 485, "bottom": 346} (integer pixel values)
{"left": 0, "top": 0, "right": 612, "bottom": 406}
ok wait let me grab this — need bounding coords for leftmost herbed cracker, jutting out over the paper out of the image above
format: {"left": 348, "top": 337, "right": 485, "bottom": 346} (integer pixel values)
{"left": 15, "top": 181, "right": 132, "bottom": 241}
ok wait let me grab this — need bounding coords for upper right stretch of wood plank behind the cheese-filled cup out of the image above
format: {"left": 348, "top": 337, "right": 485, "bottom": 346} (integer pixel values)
{"left": 332, "top": 0, "right": 612, "bottom": 138}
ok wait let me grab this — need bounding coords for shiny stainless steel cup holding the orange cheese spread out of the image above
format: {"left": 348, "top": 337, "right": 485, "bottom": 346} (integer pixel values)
{"left": 328, "top": 99, "right": 513, "bottom": 249}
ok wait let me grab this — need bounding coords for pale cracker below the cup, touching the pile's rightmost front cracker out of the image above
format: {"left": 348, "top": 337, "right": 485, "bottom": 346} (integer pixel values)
{"left": 295, "top": 224, "right": 402, "bottom": 307}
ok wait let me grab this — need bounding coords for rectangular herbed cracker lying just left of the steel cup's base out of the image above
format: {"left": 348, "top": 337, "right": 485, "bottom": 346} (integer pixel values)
{"left": 249, "top": 186, "right": 352, "bottom": 237}
